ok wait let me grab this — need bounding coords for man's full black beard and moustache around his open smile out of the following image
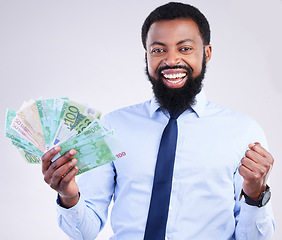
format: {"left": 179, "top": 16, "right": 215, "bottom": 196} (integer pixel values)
{"left": 146, "top": 53, "right": 206, "bottom": 114}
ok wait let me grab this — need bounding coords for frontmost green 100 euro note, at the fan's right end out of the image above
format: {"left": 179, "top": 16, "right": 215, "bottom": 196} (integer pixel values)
{"left": 52, "top": 124, "right": 126, "bottom": 175}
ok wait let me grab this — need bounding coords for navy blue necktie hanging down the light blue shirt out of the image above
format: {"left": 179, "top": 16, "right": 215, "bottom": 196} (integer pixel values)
{"left": 144, "top": 114, "right": 180, "bottom": 240}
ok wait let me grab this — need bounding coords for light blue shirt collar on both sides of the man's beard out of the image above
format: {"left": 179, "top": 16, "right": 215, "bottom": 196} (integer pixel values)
{"left": 150, "top": 89, "right": 207, "bottom": 117}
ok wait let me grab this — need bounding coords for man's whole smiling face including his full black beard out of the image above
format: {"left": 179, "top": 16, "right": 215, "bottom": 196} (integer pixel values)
{"left": 145, "top": 19, "right": 211, "bottom": 113}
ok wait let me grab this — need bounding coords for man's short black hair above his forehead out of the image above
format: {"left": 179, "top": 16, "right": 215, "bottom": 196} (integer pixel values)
{"left": 142, "top": 2, "right": 211, "bottom": 49}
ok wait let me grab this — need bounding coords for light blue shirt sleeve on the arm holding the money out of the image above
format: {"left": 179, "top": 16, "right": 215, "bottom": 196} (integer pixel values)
{"left": 57, "top": 163, "right": 115, "bottom": 240}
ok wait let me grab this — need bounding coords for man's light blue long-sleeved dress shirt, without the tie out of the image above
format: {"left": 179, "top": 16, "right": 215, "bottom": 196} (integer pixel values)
{"left": 58, "top": 91, "right": 274, "bottom": 240}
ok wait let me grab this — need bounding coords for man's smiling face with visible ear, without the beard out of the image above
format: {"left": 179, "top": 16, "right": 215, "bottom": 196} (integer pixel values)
{"left": 146, "top": 19, "right": 211, "bottom": 88}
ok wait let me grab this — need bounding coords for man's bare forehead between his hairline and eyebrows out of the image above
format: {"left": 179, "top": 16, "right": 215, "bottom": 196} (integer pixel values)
{"left": 147, "top": 19, "right": 203, "bottom": 47}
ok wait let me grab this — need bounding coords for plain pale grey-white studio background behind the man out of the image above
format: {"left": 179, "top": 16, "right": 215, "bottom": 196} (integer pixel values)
{"left": 0, "top": 0, "right": 282, "bottom": 240}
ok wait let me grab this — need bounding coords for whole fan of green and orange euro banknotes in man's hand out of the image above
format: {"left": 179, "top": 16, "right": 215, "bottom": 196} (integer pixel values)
{"left": 5, "top": 98, "right": 126, "bottom": 175}
